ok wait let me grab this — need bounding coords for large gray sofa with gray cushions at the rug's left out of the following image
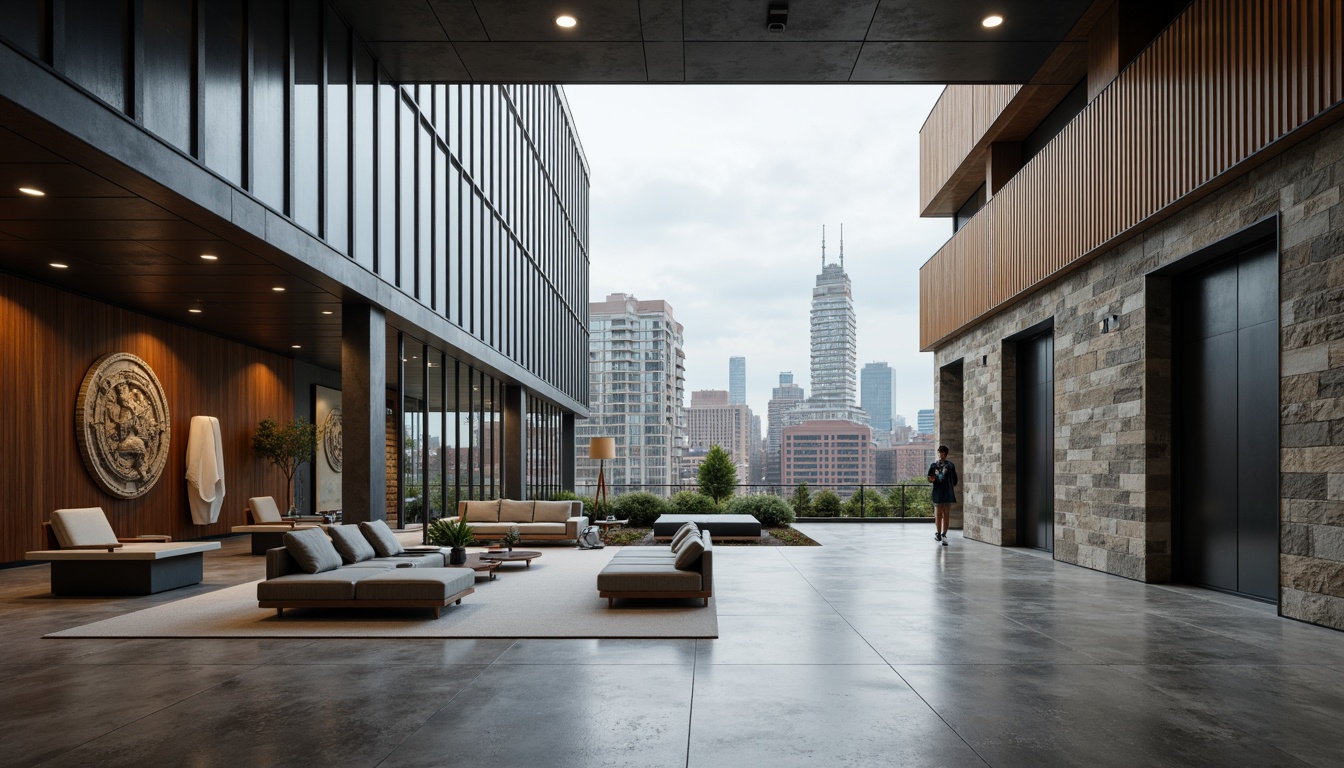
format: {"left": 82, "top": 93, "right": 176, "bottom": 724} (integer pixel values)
{"left": 257, "top": 523, "right": 476, "bottom": 619}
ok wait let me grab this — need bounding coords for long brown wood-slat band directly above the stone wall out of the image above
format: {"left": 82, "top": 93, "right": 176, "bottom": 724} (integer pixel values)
{"left": 919, "top": 0, "right": 1344, "bottom": 350}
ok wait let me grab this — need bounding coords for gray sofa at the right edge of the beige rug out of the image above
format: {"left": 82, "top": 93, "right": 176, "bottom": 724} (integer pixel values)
{"left": 597, "top": 531, "right": 714, "bottom": 608}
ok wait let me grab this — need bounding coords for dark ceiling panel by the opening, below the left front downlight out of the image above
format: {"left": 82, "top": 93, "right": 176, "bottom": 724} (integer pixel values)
{"left": 456, "top": 43, "right": 646, "bottom": 83}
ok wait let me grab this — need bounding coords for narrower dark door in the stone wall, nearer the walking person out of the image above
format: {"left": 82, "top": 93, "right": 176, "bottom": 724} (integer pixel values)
{"left": 1017, "top": 330, "right": 1055, "bottom": 551}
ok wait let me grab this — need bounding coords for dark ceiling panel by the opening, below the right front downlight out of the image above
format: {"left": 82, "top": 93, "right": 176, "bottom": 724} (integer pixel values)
{"left": 853, "top": 43, "right": 1055, "bottom": 83}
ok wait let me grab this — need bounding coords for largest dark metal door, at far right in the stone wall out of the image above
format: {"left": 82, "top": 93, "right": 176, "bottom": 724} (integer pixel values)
{"left": 1172, "top": 242, "right": 1279, "bottom": 601}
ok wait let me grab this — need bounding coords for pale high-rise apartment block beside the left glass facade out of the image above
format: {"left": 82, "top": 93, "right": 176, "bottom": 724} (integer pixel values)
{"left": 574, "top": 293, "right": 685, "bottom": 494}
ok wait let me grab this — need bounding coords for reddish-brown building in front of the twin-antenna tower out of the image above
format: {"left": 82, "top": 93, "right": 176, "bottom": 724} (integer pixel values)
{"left": 781, "top": 421, "right": 874, "bottom": 496}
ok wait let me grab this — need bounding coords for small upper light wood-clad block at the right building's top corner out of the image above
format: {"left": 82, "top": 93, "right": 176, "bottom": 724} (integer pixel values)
{"left": 919, "top": 85, "right": 1021, "bottom": 211}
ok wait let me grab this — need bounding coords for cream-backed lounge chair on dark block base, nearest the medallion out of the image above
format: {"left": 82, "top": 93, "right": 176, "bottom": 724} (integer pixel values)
{"left": 26, "top": 507, "right": 219, "bottom": 596}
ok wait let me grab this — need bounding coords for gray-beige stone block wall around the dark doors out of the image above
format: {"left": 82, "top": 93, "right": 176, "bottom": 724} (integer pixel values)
{"left": 935, "top": 117, "right": 1344, "bottom": 628}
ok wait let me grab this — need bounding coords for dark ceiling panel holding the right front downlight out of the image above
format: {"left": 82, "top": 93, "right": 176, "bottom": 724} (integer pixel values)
{"left": 865, "top": 0, "right": 1093, "bottom": 43}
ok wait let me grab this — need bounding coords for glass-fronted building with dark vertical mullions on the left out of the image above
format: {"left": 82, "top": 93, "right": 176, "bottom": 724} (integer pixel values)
{"left": 0, "top": 0, "right": 589, "bottom": 535}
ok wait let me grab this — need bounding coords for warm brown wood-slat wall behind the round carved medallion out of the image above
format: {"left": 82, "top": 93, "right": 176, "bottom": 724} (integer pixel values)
{"left": 0, "top": 274, "right": 294, "bottom": 562}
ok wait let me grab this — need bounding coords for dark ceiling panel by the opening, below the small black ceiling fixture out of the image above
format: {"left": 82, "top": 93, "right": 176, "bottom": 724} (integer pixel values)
{"left": 685, "top": 43, "right": 862, "bottom": 82}
